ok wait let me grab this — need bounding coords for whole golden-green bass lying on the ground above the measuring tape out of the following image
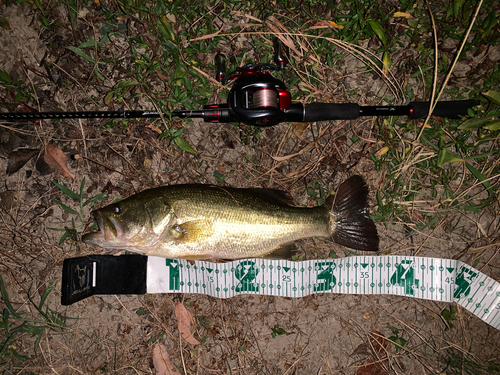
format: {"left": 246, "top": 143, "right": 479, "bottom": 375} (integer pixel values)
{"left": 82, "top": 175, "right": 379, "bottom": 261}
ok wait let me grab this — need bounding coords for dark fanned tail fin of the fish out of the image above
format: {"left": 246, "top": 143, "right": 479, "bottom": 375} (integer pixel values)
{"left": 330, "top": 176, "right": 379, "bottom": 251}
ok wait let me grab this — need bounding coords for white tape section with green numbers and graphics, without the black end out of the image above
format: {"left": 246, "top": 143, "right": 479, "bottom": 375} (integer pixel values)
{"left": 147, "top": 255, "right": 500, "bottom": 329}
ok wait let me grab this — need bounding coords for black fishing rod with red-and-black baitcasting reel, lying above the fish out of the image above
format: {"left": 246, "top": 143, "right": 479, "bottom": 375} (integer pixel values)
{"left": 0, "top": 38, "right": 479, "bottom": 126}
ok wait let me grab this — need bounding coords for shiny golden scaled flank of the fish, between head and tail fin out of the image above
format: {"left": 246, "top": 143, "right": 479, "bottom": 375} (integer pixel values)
{"left": 162, "top": 185, "right": 329, "bottom": 259}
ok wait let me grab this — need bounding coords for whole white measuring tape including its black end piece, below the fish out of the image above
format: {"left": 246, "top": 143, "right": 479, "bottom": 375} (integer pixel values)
{"left": 62, "top": 255, "right": 500, "bottom": 329}
